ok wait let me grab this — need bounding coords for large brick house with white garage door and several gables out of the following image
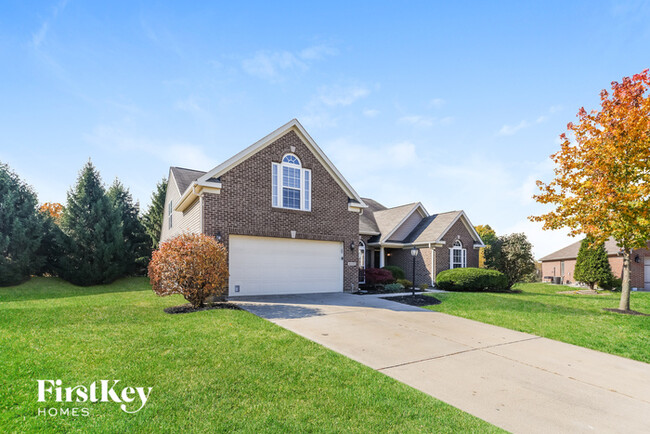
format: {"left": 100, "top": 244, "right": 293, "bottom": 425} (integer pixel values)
{"left": 160, "top": 119, "right": 483, "bottom": 296}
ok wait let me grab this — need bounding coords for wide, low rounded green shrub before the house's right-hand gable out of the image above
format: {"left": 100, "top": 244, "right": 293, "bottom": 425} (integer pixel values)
{"left": 436, "top": 268, "right": 509, "bottom": 291}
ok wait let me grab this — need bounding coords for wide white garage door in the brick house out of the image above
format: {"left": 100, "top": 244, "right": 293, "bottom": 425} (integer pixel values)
{"left": 229, "top": 235, "right": 343, "bottom": 295}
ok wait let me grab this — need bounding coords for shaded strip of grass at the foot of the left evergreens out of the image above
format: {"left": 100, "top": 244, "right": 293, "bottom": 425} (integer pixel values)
{"left": 0, "top": 277, "right": 151, "bottom": 303}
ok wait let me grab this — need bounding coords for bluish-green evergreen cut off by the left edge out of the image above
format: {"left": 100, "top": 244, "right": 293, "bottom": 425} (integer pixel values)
{"left": 0, "top": 163, "right": 42, "bottom": 286}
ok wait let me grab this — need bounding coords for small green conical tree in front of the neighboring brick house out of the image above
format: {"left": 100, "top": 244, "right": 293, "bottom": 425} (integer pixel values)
{"left": 573, "top": 237, "right": 614, "bottom": 289}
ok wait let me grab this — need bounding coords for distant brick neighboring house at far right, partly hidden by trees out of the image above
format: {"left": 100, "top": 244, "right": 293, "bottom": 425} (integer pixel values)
{"left": 539, "top": 238, "right": 650, "bottom": 289}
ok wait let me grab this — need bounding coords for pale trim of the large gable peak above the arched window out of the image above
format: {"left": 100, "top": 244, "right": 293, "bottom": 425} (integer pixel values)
{"left": 198, "top": 119, "right": 366, "bottom": 208}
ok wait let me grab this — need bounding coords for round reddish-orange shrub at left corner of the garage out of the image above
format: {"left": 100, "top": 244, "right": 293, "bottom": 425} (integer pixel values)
{"left": 149, "top": 234, "right": 228, "bottom": 308}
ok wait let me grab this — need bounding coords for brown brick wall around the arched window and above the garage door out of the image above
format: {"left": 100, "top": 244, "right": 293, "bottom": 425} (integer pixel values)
{"left": 203, "top": 131, "right": 359, "bottom": 291}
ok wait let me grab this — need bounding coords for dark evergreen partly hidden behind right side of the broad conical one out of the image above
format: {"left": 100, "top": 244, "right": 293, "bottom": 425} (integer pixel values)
{"left": 106, "top": 179, "right": 151, "bottom": 275}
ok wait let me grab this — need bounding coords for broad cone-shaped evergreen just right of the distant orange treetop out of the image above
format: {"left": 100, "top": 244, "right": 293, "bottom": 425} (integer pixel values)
{"left": 60, "top": 161, "right": 124, "bottom": 286}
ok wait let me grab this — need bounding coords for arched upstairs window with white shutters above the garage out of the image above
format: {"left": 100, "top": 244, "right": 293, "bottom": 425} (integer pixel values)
{"left": 271, "top": 154, "right": 312, "bottom": 211}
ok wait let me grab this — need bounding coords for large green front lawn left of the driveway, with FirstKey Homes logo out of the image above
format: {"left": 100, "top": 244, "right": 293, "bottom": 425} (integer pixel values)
{"left": 0, "top": 278, "right": 496, "bottom": 432}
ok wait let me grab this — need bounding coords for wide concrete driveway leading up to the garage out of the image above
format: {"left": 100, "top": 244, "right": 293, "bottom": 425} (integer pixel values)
{"left": 233, "top": 293, "right": 650, "bottom": 433}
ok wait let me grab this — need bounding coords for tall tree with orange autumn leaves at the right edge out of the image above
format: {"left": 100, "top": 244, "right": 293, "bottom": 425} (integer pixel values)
{"left": 530, "top": 69, "right": 650, "bottom": 311}
